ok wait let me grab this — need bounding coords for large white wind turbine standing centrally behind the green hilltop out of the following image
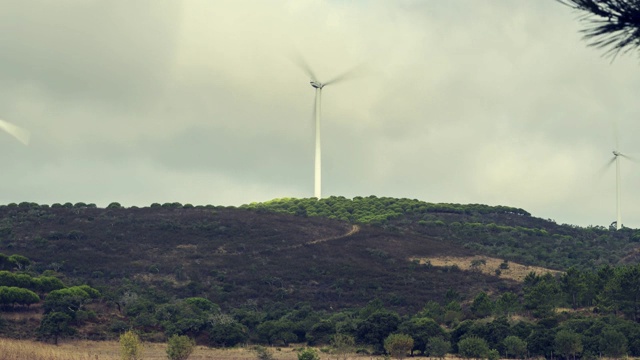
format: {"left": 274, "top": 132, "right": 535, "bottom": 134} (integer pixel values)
{"left": 297, "top": 56, "right": 356, "bottom": 200}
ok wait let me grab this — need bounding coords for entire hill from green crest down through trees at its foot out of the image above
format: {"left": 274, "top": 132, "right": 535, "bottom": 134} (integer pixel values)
{"left": 0, "top": 196, "right": 640, "bottom": 354}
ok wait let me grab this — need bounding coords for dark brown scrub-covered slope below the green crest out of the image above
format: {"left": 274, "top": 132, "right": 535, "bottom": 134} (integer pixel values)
{"left": 0, "top": 204, "right": 511, "bottom": 310}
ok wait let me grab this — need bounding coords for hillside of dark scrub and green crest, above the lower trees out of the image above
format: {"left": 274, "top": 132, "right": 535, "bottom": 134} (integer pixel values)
{"left": 0, "top": 196, "right": 640, "bottom": 316}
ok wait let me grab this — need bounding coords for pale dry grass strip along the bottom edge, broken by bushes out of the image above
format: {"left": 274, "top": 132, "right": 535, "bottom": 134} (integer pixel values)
{"left": 0, "top": 339, "right": 381, "bottom": 360}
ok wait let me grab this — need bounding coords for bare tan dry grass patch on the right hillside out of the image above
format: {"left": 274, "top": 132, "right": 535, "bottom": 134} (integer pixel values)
{"left": 409, "top": 256, "right": 560, "bottom": 282}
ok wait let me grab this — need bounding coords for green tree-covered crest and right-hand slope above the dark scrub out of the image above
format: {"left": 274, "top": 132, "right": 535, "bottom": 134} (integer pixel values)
{"left": 242, "top": 196, "right": 640, "bottom": 270}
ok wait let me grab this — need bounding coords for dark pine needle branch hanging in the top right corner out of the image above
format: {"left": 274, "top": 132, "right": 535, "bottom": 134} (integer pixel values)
{"left": 557, "top": 0, "right": 640, "bottom": 57}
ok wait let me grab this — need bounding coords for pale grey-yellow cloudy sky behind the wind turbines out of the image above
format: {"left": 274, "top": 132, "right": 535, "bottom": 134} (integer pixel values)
{"left": 0, "top": 0, "right": 640, "bottom": 227}
